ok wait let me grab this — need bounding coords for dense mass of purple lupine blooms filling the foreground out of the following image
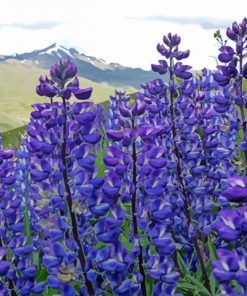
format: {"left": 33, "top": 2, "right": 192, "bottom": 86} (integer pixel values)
{"left": 0, "top": 18, "right": 247, "bottom": 296}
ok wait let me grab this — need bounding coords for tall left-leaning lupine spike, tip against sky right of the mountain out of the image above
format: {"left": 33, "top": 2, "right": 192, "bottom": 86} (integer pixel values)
{"left": 149, "top": 34, "right": 237, "bottom": 291}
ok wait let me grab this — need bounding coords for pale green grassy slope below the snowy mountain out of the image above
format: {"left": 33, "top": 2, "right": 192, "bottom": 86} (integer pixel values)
{"left": 0, "top": 61, "right": 135, "bottom": 132}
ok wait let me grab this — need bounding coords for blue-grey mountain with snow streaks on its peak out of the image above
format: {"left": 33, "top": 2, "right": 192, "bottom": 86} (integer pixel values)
{"left": 0, "top": 43, "right": 162, "bottom": 89}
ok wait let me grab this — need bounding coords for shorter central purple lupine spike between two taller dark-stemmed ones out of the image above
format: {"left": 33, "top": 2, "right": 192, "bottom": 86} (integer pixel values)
{"left": 92, "top": 91, "right": 179, "bottom": 295}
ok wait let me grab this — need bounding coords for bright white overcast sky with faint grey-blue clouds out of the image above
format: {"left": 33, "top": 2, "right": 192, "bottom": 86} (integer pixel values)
{"left": 0, "top": 0, "right": 247, "bottom": 69}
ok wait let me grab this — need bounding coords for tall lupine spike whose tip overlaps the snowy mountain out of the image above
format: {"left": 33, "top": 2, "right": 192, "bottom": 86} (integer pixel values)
{"left": 27, "top": 59, "right": 103, "bottom": 295}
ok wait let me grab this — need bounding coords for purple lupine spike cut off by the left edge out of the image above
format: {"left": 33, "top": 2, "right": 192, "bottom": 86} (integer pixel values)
{"left": 0, "top": 140, "right": 46, "bottom": 295}
